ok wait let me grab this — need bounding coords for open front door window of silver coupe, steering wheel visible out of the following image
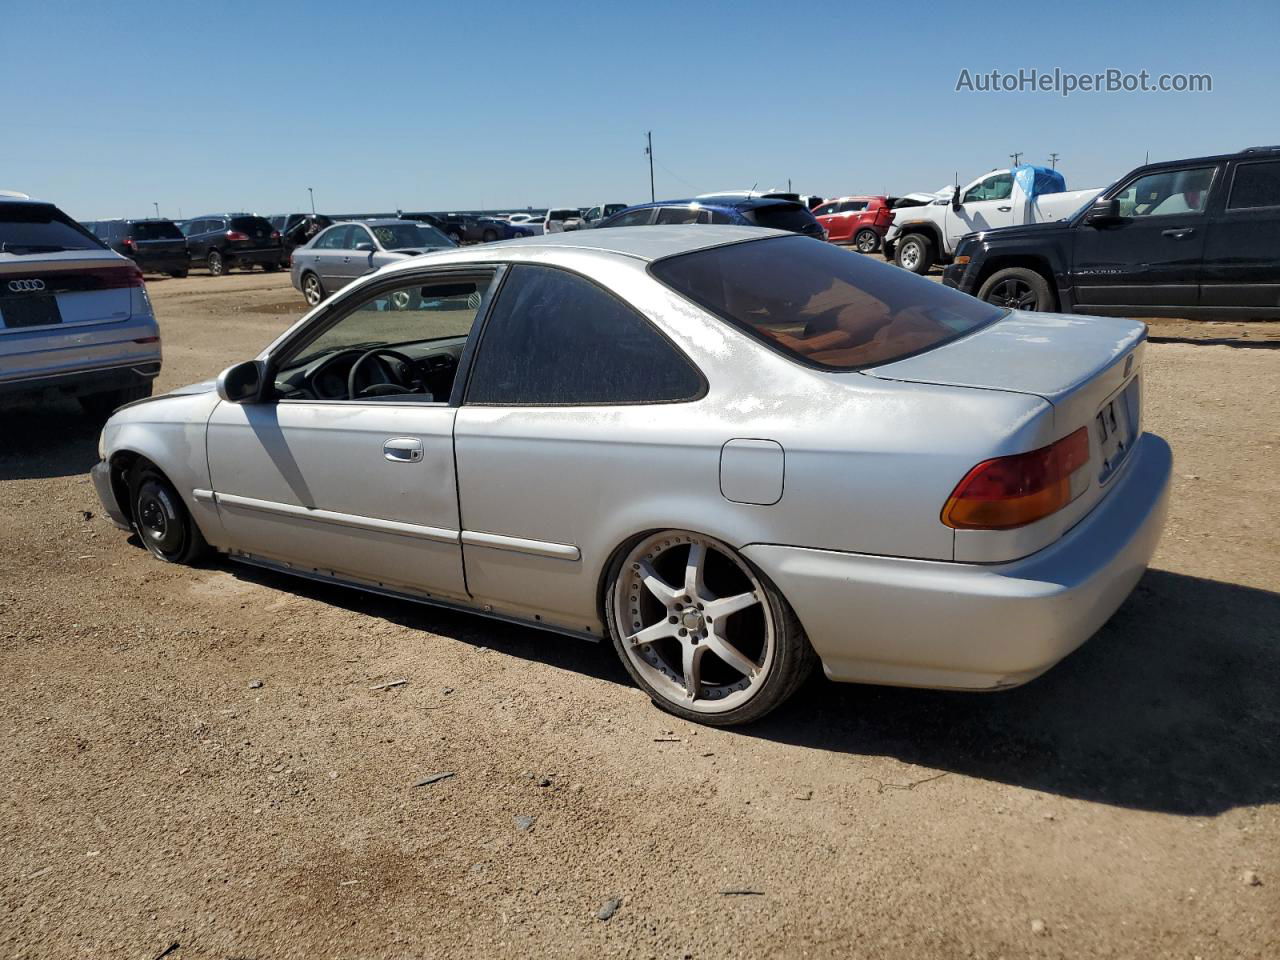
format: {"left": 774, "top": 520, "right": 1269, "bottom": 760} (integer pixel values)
{"left": 271, "top": 271, "right": 493, "bottom": 403}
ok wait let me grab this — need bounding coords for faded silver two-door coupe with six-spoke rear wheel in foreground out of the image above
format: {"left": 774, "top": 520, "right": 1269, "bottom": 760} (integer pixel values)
{"left": 92, "top": 225, "right": 1172, "bottom": 724}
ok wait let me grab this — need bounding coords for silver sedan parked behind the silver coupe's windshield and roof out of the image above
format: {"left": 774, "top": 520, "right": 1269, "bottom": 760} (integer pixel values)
{"left": 289, "top": 219, "right": 457, "bottom": 306}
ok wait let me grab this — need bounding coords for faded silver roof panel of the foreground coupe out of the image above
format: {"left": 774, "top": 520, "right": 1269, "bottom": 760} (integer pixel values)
{"left": 389, "top": 224, "right": 797, "bottom": 262}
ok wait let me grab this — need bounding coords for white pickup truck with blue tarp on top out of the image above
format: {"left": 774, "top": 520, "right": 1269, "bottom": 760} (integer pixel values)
{"left": 884, "top": 164, "right": 1102, "bottom": 274}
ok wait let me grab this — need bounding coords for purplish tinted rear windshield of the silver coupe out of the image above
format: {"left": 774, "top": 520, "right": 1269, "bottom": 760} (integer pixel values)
{"left": 650, "top": 237, "right": 1006, "bottom": 370}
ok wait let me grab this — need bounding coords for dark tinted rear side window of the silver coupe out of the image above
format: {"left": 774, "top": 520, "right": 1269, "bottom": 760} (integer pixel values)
{"left": 466, "top": 264, "right": 703, "bottom": 406}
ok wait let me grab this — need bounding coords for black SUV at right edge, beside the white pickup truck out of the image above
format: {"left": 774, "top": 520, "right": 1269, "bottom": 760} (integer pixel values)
{"left": 942, "top": 147, "right": 1280, "bottom": 319}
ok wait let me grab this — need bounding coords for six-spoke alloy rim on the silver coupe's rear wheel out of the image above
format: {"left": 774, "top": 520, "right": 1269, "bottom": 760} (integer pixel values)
{"left": 612, "top": 531, "right": 777, "bottom": 713}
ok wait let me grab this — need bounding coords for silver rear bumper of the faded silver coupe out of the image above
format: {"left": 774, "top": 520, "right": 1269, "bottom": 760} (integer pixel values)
{"left": 744, "top": 434, "right": 1172, "bottom": 690}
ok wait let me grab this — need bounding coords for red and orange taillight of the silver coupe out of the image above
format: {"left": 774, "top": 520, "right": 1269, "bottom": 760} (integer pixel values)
{"left": 942, "top": 426, "right": 1089, "bottom": 530}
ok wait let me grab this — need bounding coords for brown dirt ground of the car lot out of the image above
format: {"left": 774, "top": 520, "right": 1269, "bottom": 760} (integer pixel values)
{"left": 0, "top": 274, "right": 1280, "bottom": 960}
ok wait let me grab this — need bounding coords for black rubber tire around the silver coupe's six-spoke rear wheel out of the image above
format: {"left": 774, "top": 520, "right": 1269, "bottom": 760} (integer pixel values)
{"left": 604, "top": 531, "right": 818, "bottom": 727}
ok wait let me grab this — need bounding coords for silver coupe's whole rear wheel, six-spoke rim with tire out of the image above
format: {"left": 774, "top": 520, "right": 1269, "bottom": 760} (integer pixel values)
{"left": 605, "top": 530, "right": 817, "bottom": 727}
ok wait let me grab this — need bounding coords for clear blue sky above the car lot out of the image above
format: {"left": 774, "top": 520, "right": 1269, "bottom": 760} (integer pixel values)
{"left": 0, "top": 0, "right": 1280, "bottom": 219}
